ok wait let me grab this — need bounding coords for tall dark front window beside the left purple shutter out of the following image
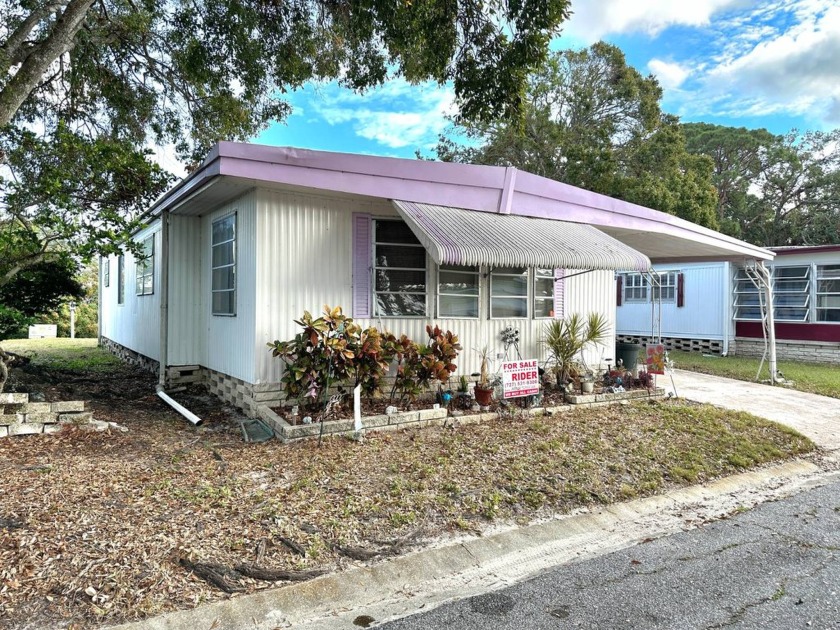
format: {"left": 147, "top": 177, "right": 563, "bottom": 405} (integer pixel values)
{"left": 373, "top": 220, "right": 426, "bottom": 317}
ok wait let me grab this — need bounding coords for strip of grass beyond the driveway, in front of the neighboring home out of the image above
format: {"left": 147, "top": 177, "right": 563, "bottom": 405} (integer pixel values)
{"left": 668, "top": 350, "right": 840, "bottom": 398}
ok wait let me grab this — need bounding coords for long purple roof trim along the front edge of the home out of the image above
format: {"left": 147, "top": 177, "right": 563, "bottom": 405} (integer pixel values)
{"left": 156, "top": 142, "right": 773, "bottom": 259}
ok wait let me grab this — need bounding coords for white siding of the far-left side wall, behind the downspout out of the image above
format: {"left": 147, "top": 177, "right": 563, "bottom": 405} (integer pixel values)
{"left": 99, "top": 221, "right": 161, "bottom": 359}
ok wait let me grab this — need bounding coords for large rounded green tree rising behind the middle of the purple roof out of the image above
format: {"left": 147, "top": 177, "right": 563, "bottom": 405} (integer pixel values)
{"left": 437, "top": 42, "right": 717, "bottom": 227}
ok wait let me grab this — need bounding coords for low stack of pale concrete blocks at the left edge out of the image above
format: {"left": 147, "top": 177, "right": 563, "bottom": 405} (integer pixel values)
{"left": 0, "top": 394, "right": 93, "bottom": 438}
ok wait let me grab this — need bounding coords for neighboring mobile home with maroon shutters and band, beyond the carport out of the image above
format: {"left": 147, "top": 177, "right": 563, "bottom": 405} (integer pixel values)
{"left": 617, "top": 245, "right": 840, "bottom": 363}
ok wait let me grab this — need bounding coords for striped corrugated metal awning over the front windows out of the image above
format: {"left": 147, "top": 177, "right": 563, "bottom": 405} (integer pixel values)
{"left": 393, "top": 200, "right": 651, "bottom": 271}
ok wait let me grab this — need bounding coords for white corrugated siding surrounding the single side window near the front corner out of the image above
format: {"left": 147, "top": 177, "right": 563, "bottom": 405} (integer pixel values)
{"left": 202, "top": 191, "right": 257, "bottom": 383}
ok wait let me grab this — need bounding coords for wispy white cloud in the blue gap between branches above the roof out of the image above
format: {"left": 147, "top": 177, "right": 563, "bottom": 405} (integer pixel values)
{"left": 309, "top": 79, "right": 455, "bottom": 149}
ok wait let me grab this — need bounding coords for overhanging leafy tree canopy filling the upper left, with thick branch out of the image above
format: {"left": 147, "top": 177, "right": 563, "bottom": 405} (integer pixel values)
{"left": 0, "top": 0, "right": 569, "bottom": 284}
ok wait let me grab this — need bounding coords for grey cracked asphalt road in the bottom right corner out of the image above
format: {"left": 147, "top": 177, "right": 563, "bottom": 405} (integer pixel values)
{"left": 378, "top": 480, "right": 840, "bottom": 630}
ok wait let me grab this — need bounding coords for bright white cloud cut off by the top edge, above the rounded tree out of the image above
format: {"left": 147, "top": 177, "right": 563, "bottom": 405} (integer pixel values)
{"left": 566, "top": 0, "right": 744, "bottom": 43}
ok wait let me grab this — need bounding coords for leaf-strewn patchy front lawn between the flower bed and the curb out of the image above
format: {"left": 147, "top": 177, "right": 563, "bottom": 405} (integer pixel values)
{"left": 0, "top": 344, "right": 814, "bottom": 628}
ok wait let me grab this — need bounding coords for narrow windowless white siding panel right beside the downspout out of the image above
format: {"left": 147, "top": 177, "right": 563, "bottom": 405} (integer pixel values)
{"left": 168, "top": 215, "right": 209, "bottom": 365}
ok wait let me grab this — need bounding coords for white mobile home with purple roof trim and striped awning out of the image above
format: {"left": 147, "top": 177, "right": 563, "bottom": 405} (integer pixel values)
{"left": 100, "top": 142, "right": 773, "bottom": 414}
